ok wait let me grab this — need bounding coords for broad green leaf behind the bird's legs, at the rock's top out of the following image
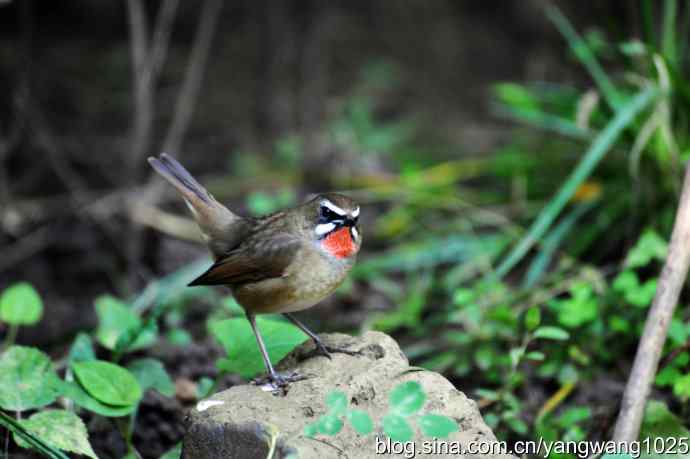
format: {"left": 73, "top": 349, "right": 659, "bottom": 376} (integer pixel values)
{"left": 209, "top": 316, "right": 307, "bottom": 378}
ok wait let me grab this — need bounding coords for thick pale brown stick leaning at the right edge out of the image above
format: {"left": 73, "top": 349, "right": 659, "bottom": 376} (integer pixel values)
{"left": 613, "top": 167, "right": 690, "bottom": 441}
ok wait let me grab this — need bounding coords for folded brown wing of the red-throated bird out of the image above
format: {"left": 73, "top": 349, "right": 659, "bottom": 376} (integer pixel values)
{"left": 189, "top": 234, "right": 304, "bottom": 286}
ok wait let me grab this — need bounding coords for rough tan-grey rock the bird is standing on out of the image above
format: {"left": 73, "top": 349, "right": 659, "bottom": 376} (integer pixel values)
{"left": 182, "top": 332, "right": 511, "bottom": 459}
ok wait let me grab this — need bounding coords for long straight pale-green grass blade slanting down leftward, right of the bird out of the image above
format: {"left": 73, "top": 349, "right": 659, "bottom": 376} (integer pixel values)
{"left": 496, "top": 87, "right": 658, "bottom": 278}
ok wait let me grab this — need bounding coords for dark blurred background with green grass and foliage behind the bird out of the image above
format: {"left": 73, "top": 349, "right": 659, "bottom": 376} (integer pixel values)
{"left": 0, "top": 0, "right": 690, "bottom": 457}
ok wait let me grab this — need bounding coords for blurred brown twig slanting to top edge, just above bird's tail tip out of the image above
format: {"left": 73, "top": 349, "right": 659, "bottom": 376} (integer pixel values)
{"left": 163, "top": 0, "right": 223, "bottom": 154}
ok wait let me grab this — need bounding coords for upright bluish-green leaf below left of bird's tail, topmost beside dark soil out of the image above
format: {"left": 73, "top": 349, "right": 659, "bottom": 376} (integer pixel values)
{"left": 95, "top": 295, "right": 155, "bottom": 351}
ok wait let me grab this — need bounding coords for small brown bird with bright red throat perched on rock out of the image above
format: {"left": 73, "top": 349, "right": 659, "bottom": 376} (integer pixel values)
{"left": 149, "top": 153, "right": 362, "bottom": 386}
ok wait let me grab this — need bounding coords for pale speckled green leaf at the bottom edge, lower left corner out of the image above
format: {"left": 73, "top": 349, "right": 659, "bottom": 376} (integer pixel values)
{"left": 14, "top": 410, "right": 97, "bottom": 459}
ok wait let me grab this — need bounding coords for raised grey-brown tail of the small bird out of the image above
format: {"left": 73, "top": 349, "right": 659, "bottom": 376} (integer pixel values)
{"left": 149, "top": 153, "right": 240, "bottom": 240}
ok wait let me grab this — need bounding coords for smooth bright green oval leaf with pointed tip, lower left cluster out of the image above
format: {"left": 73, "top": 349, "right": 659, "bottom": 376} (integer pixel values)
{"left": 72, "top": 360, "right": 142, "bottom": 406}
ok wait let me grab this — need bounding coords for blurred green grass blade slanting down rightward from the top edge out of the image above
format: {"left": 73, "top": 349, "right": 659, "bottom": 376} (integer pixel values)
{"left": 546, "top": 5, "right": 623, "bottom": 111}
